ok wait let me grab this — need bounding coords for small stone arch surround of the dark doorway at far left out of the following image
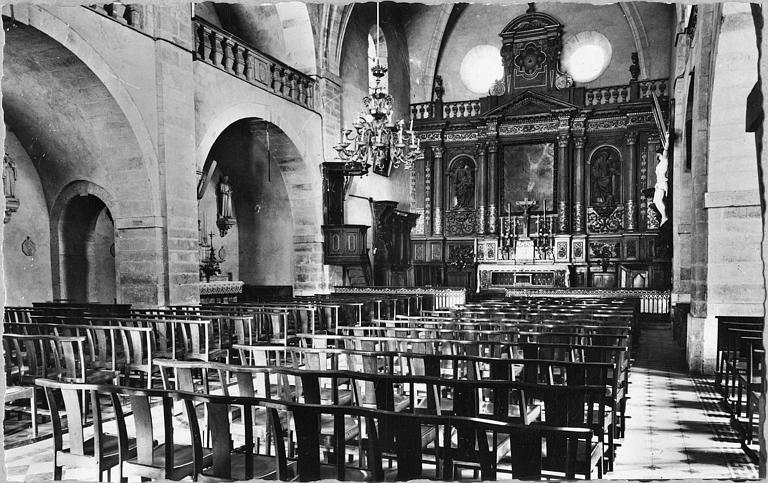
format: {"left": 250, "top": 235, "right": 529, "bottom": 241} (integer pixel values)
{"left": 49, "top": 180, "right": 122, "bottom": 300}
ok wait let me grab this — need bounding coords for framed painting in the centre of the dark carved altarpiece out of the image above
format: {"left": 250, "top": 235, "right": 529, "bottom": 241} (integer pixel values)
{"left": 502, "top": 143, "right": 555, "bottom": 212}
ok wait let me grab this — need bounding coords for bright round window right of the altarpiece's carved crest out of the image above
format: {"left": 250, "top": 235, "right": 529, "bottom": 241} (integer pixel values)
{"left": 561, "top": 30, "right": 612, "bottom": 83}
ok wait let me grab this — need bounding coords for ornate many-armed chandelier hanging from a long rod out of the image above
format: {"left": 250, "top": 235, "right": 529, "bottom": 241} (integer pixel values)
{"left": 333, "top": 2, "right": 422, "bottom": 176}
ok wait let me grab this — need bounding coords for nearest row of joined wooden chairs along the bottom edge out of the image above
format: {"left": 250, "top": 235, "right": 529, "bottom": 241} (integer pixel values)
{"left": 38, "top": 380, "right": 592, "bottom": 481}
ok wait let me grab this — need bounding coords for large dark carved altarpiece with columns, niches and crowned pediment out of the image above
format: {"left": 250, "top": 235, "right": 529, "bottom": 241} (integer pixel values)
{"left": 410, "top": 9, "right": 672, "bottom": 292}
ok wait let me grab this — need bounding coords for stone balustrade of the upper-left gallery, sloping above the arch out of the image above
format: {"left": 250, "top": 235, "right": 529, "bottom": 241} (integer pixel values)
{"left": 193, "top": 17, "right": 315, "bottom": 110}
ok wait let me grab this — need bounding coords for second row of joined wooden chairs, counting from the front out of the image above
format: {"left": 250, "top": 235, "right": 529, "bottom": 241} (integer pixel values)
{"left": 153, "top": 361, "right": 612, "bottom": 476}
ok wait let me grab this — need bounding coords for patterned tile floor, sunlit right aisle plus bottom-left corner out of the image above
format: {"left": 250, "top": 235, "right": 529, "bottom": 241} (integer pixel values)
{"left": 5, "top": 329, "right": 758, "bottom": 481}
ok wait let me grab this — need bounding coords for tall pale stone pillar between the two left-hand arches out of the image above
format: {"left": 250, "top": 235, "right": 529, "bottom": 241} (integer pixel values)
{"left": 151, "top": 4, "right": 200, "bottom": 304}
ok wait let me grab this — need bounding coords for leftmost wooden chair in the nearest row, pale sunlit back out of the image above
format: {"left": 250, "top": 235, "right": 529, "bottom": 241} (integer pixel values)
{"left": 35, "top": 379, "right": 136, "bottom": 481}
